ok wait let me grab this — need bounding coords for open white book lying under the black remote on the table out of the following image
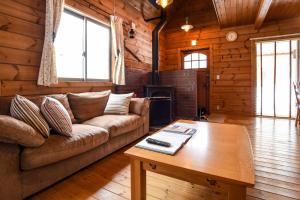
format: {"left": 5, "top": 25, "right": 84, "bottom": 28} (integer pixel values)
{"left": 135, "top": 131, "right": 192, "bottom": 155}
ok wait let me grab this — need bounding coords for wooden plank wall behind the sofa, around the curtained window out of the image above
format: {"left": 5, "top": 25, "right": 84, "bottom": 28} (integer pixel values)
{"left": 0, "top": 0, "right": 153, "bottom": 96}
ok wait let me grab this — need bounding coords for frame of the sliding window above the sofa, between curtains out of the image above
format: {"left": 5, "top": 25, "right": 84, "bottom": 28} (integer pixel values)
{"left": 58, "top": 6, "right": 112, "bottom": 82}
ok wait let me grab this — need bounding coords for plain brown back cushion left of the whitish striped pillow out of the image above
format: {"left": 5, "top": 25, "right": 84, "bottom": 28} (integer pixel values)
{"left": 68, "top": 91, "right": 110, "bottom": 122}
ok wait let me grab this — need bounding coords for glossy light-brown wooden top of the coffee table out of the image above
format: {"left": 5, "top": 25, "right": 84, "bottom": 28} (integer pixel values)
{"left": 125, "top": 120, "right": 255, "bottom": 186}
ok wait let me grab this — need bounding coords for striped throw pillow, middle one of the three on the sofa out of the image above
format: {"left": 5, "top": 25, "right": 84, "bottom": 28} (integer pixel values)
{"left": 41, "top": 97, "right": 72, "bottom": 136}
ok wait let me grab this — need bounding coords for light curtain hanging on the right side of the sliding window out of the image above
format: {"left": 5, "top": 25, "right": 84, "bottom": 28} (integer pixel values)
{"left": 110, "top": 16, "right": 125, "bottom": 85}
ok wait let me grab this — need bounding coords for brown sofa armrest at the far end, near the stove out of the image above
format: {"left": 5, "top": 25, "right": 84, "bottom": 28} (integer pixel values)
{"left": 129, "top": 98, "right": 150, "bottom": 116}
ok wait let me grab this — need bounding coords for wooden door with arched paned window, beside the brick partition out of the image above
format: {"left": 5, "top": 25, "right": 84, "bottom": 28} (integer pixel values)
{"left": 182, "top": 49, "right": 209, "bottom": 116}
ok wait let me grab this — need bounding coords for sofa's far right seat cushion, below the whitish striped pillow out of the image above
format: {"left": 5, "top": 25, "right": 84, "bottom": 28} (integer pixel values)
{"left": 83, "top": 114, "right": 143, "bottom": 137}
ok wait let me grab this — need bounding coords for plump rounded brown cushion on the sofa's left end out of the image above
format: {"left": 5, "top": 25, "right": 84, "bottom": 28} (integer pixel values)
{"left": 0, "top": 115, "right": 46, "bottom": 147}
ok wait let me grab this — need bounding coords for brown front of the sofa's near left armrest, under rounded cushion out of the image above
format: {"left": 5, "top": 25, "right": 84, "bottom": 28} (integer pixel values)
{"left": 0, "top": 142, "right": 22, "bottom": 200}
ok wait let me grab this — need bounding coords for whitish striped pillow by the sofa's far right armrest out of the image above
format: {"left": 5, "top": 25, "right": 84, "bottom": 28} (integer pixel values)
{"left": 104, "top": 93, "right": 133, "bottom": 115}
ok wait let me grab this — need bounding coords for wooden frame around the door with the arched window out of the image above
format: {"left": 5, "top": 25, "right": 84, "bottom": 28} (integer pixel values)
{"left": 177, "top": 44, "right": 213, "bottom": 114}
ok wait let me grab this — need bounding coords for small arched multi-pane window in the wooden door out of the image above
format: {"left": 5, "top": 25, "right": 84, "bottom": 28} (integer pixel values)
{"left": 183, "top": 52, "right": 207, "bottom": 69}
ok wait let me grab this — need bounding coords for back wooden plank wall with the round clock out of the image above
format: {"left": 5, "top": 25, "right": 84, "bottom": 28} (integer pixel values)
{"left": 160, "top": 11, "right": 300, "bottom": 115}
